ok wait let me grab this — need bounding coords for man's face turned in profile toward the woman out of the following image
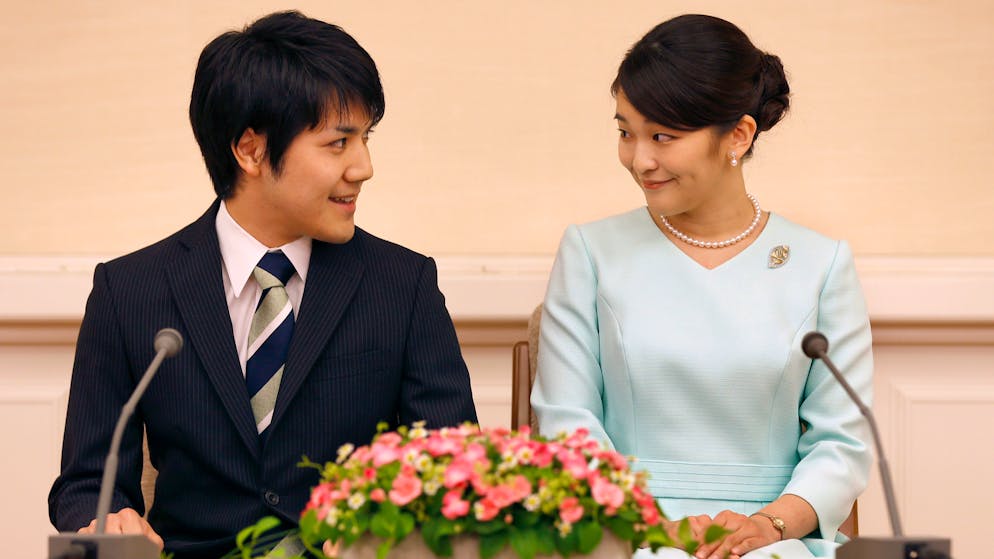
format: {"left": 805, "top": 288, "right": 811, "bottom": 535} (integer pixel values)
{"left": 235, "top": 110, "right": 373, "bottom": 247}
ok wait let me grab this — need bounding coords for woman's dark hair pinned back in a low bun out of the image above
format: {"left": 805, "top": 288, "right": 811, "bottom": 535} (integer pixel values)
{"left": 611, "top": 15, "right": 790, "bottom": 156}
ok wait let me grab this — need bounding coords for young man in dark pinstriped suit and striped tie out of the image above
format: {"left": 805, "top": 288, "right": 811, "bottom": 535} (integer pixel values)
{"left": 49, "top": 12, "right": 476, "bottom": 559}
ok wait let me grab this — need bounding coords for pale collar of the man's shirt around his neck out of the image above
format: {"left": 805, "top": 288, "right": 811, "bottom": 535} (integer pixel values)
{"left": 214, "top": 201, "right": 311, "bottom": 297}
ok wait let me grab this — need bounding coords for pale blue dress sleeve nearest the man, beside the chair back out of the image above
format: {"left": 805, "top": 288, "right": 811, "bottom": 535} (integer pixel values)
{"left": 531, "top": 226, "right": 612, "bottom": 444}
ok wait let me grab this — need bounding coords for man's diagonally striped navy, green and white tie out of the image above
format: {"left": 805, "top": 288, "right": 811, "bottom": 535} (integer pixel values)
{"left": 245, "top": 252, "right": 296, "bottom": 434}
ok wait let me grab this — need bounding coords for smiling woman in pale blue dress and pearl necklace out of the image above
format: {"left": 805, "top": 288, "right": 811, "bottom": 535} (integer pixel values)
{"left": 532, "top": 15, "right": 873, "bottom": 559}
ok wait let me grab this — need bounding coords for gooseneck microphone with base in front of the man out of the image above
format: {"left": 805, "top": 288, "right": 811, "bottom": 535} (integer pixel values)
{"left": 48, "top": 328, "right": 183, "bottom": 559}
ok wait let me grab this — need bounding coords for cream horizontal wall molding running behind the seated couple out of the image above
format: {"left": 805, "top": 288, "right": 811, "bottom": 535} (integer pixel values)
{"left": 0, "top": 255, "right": 994, "bottom": 345}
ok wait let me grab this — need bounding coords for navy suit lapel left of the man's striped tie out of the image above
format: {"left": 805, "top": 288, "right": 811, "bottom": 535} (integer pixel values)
{"left": 167, "top": 201, "right": 259, "bottom": 457}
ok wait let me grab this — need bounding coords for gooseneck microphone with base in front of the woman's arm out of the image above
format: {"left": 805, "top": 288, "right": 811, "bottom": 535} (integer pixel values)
{"left": 801, "top": 332, "right": 950, "bottom": 559}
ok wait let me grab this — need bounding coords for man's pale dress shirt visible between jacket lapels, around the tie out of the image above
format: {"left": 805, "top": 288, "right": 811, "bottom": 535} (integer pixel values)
{"left": 215, "top": 201, "right": 311, "bottom": 375}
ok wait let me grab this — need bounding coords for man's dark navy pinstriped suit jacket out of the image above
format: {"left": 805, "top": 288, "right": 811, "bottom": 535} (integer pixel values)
{"left": 49, "top": 202, "right": 476, "bottom": 559}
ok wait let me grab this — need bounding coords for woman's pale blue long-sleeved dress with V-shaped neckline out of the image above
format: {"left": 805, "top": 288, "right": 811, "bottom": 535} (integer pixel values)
{"left": 531, "top": 207, "right": 873, "bottom": 559}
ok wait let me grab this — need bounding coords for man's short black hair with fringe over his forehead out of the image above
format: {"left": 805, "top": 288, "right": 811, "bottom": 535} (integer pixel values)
{"left": 190, "top": 11, "right": 385, "bottom": 198}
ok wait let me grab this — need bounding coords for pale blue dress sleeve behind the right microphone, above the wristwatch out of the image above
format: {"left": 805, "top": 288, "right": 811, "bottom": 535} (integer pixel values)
{"left": 784, "top": 242, "right": 873, "bottom": 540}
